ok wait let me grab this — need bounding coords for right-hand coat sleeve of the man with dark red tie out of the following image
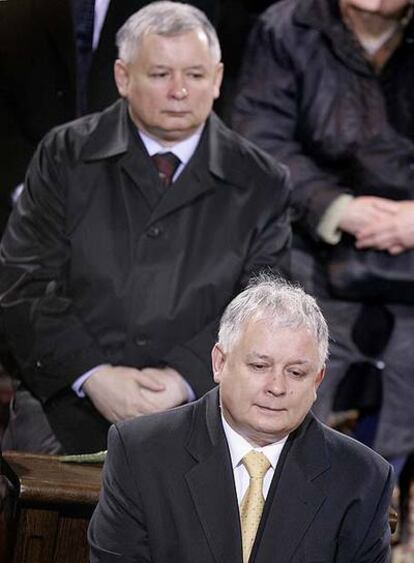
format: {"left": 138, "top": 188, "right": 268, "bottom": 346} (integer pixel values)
{"left": 164, "top": 159, "right": 291, "bottom": 397}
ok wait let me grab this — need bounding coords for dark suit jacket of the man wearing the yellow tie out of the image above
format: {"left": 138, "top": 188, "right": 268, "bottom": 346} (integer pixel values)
{"left": 89, "top": 389, "right": 393, "bottom": 563}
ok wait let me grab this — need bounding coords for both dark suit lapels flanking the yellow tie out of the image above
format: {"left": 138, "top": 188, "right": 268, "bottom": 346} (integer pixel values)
{"left": 186, "top": 394, "right": 330, "bottom": 563}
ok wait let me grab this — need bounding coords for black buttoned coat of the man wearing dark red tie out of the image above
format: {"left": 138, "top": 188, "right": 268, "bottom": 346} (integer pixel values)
{"left": 0, "top": 101, "right": 290, "bottom": 451}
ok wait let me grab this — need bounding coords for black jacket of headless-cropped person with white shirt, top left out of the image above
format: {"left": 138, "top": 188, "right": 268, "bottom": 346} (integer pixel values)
{"left": 0, "top": 0, "right": 219, "bottom": 232}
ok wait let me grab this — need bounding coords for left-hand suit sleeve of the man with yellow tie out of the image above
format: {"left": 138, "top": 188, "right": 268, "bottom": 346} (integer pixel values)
{"left": 88, "top": 426, "right": 152, "bottom": 563}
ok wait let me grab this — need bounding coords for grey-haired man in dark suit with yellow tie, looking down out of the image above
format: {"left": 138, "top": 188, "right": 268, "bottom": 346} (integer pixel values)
{"left": 89, "top": 276, "right": 393, "bottom": 563}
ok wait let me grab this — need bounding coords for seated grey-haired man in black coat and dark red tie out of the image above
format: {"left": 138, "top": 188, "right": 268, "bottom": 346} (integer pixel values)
{"left": 0, "top": 2, "right": 290, "bottom": 453}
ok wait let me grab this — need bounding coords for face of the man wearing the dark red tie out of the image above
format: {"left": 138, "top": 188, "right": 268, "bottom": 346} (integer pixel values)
{"left": 115, "top": 30, "right": 223, "bottom": 145}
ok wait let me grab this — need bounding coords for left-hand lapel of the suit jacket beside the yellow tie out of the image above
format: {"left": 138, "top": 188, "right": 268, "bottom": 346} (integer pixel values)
{"left": 185, "top": 389, "right": 242, "bottom": 563}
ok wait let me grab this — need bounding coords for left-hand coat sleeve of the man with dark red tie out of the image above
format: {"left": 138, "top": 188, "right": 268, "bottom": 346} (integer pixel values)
{"left": 0, "top": 134, "right": 105, "bottom": 401}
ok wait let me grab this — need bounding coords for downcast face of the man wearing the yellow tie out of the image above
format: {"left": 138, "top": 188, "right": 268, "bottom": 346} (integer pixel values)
{"left": 212, "top": 319, "right": 324, "bottom": 446}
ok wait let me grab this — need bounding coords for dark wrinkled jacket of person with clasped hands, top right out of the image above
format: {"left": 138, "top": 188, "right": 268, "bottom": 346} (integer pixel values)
{"left": 233, "top": 0, "right": 414, "bottom": 247}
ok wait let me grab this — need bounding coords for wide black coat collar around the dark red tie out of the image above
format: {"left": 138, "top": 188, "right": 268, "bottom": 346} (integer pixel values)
{"left": 81, "top": 100, "right": 248, "bottom": 223}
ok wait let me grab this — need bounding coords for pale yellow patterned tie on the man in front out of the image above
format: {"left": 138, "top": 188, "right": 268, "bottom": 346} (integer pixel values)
{"left": 240, "top": 450, "right": 270, "bottom": 563}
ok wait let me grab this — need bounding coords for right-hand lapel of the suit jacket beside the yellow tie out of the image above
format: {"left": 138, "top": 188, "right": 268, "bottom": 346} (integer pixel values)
{"left": 253, "top": 415, "right": 330, "bottom": 563}
